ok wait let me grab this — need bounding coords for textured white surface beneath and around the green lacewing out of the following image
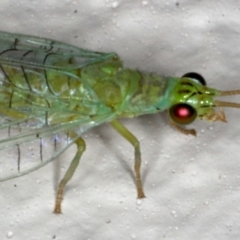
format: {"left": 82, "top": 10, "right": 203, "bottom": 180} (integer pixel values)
{"left": 0, "top": 0, "right": 240, "bottom": 240}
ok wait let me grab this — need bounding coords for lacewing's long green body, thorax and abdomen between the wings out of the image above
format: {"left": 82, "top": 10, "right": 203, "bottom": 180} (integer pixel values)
{"left": 0, "top": 51, "right": 219, "bottom": 125}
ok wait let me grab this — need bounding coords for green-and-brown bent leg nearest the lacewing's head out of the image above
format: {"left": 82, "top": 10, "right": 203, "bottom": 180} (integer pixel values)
{"left": 110, "top": 120, "right": 145, "bottom": 198}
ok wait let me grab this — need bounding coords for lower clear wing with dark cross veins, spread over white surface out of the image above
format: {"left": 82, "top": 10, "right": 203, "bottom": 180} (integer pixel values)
{"left": 0, "top": 111, "right": 114, "bottom": 181}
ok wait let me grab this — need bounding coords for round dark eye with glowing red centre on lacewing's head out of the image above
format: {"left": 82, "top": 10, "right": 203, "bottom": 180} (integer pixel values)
{"left": 169, "top": 103, "right": 197, "bottom": 125}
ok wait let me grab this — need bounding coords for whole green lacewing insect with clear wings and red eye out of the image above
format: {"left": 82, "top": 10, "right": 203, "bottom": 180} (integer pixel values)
{"left": 0, "top": 32, "right": 240, "bottom": 214}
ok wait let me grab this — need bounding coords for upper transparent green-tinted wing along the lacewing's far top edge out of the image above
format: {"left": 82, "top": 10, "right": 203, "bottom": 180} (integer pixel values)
{"left": 0, "top": 31, "right": 116, "bottom": 70}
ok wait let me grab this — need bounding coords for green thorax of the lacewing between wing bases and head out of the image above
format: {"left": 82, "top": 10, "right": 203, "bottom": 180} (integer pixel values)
{"left": 81, "top": 57, "right": 171, "bottom": 117}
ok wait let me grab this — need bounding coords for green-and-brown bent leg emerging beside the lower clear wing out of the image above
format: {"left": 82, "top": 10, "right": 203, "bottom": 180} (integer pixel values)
{"left": 53, "top": 132, "right": 86, "bottom": 214}
